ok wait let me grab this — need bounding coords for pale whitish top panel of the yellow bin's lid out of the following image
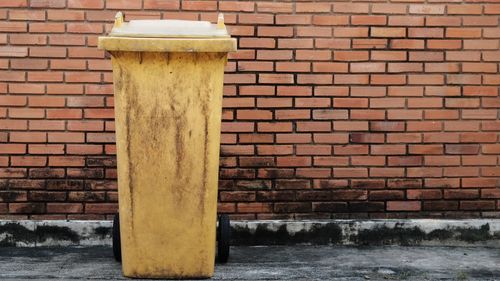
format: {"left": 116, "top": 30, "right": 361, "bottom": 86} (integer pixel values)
{"left": 109, "top": 20, "right": 229, "bottom": 38}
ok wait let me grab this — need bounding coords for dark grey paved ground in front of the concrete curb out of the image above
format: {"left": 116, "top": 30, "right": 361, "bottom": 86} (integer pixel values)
{"left": 0, "top": 246, "right": 500, "bottom": 281}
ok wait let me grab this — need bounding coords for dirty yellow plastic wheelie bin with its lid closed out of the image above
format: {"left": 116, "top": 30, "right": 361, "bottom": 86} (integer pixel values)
{"left": 99, "top": 13, "right": 236, "bottom": 278}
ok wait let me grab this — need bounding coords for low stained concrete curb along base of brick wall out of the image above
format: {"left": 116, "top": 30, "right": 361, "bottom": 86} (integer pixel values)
{"left": 0, "top": 219, "right": 500, "bottom": 248}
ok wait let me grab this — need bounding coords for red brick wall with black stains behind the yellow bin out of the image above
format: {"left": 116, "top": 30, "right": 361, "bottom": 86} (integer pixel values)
{"left": 0, "top": 0, "right": 500, "bottom": 219}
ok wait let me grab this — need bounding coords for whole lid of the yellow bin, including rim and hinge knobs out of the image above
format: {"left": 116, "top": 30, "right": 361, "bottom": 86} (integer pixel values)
{"left": 98, "top": 12, "right": 236, "bottom": 52}
